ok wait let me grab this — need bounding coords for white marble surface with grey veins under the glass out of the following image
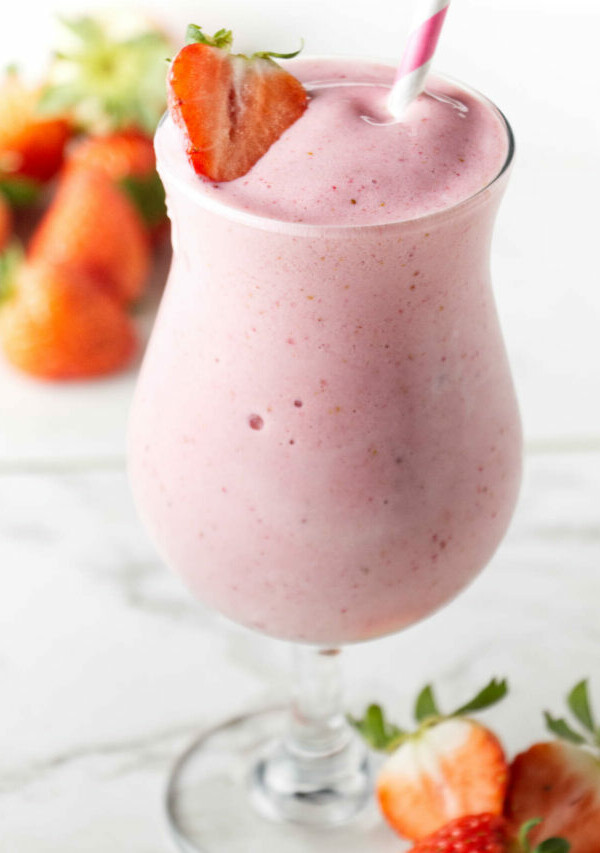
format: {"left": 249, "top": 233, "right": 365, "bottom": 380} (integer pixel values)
{"left": 0, "top": 452, "right": 600, "bottom": 853}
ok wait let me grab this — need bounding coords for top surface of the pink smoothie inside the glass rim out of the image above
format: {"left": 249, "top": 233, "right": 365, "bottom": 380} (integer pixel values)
{"left": 166, "top": 59, "right": 507, "bottom": 225}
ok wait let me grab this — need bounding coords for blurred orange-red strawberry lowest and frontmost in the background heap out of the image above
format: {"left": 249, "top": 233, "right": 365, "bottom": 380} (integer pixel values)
{"left": 0, "top": 251, "right": 135, "bottom": 379}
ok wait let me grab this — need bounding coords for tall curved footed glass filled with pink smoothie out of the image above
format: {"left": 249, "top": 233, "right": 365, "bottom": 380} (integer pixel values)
{"left": 129, "top": 70, "right": 521, "bottom": 853}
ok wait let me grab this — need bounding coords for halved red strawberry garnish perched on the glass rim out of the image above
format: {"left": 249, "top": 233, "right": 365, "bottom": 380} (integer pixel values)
{"left": 167, "top": 25, "right": 307, "bottom": 181}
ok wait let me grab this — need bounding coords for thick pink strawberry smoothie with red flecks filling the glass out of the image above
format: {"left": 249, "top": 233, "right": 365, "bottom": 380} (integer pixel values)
{"left": 130, "top": 60, "right": 521, "bottom": 644}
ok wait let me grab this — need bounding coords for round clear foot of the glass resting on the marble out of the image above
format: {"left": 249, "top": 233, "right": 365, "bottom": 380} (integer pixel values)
{"left": 166, "top": 708, "right": 409, "bottom": 853}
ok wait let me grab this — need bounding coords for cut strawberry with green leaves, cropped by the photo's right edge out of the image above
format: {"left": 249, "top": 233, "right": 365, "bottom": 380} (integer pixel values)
{"left": 505, "top": 681, "right": 600, "bottom": 853}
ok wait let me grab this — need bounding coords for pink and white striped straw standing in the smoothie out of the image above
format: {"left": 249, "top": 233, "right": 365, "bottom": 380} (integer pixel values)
{"left": 388, "top": 0, "right": 450, "bottom": 118}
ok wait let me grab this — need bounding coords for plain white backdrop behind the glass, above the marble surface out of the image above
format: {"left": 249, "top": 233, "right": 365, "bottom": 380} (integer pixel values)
{"left": 0, "top": 0, "right": 600, "bottom": 453}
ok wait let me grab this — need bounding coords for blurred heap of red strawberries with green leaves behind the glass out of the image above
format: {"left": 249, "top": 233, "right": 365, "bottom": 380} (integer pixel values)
{"left": 0, "top": 12, "right": 173, "bottom": 379}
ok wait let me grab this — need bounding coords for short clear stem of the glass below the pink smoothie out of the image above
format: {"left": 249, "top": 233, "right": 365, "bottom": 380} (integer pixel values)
{"left": 286, "top": 645, "right": 352, "bottom": 758}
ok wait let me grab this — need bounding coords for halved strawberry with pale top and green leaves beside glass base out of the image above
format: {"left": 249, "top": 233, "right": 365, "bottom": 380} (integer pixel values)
{"left": 352, "top": 680, "right": 508, "bottom": 840}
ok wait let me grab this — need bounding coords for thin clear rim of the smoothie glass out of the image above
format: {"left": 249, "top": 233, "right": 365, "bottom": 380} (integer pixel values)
{"left": 154, "top": 65, "right": 515, "bottom": 236}
